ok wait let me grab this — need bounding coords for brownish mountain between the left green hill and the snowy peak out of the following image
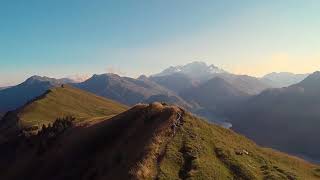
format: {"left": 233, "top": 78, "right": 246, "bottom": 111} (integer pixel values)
{"left": 74, "top": 74, "right": 190, "bottom": 108}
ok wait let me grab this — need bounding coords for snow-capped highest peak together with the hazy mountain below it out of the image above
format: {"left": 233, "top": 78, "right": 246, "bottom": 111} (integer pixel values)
{"left": 149, "top": 62, "right": 272, "bottom": 123}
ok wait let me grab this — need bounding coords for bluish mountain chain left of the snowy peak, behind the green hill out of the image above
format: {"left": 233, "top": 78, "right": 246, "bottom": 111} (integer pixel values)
{"left": 0, "top": 74, "right": 191, "bottom": 113}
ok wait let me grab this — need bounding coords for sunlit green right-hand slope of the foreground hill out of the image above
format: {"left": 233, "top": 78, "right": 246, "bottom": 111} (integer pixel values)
{"left": 158, "top": 115, "right": 320, "bottom": 180}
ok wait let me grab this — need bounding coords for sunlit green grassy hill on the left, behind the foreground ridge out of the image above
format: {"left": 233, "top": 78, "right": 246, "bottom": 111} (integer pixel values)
{"left": 18, "top": 85, "right": 127, "bottom": 127}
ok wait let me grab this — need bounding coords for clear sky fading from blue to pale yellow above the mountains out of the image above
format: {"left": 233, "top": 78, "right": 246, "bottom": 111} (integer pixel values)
{"left": 0, "top": 0, "right": 320, "bottom": 86}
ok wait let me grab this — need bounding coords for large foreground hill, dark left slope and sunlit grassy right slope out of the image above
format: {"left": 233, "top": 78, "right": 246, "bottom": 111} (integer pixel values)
{"left": 0, "top": 103, "right": 320, "bottom": 180}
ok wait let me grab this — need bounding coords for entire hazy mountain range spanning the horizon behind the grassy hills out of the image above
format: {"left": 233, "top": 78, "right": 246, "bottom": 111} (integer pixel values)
{"left": 0, "top": 62, "right": 320, "bottom": 165}
